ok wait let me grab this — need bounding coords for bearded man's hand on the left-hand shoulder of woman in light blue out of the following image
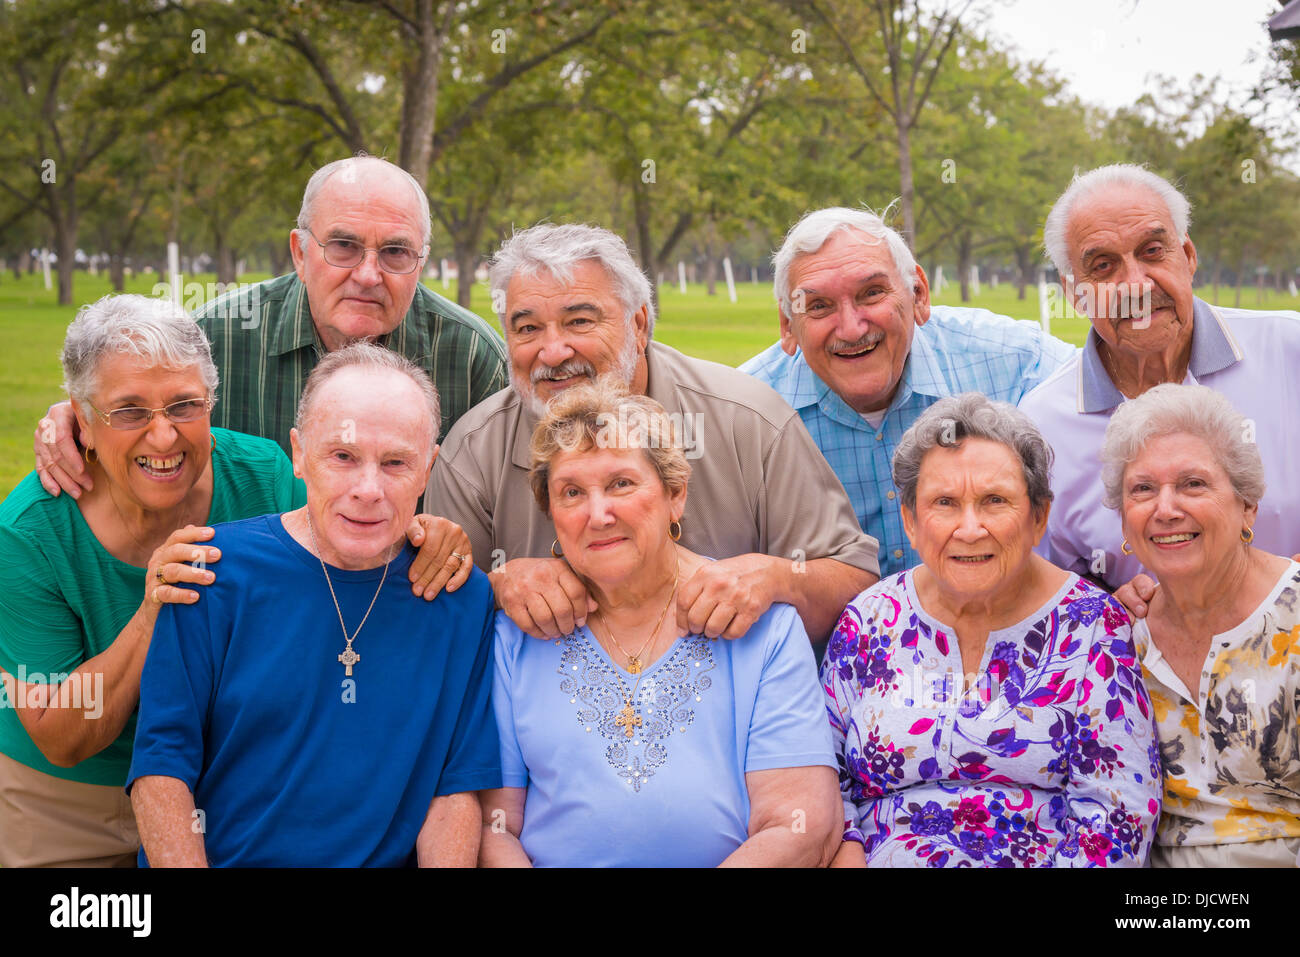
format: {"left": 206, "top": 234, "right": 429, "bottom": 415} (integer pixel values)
{"left": 489, "top": 558, "right": 595, "bottom": 638}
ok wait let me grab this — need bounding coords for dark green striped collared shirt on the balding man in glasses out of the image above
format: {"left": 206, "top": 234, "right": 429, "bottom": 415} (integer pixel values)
{"left": 195, "top": 273, "right": 508, "bottom": 454}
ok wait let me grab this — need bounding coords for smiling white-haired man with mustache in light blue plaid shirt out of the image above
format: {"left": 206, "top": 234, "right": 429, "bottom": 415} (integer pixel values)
{"left": 740, "top": 207, "right": 1078, "bottom": 576}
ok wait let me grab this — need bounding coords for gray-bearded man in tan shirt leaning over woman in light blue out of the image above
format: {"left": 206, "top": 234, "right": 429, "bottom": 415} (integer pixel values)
{"left": 425, "top": 225, "right": 879, "bottom": 641}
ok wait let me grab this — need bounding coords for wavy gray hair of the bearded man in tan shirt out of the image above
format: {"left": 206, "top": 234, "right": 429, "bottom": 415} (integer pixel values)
{"left": 488, "top": 222, "right": 654, "bottom": 338}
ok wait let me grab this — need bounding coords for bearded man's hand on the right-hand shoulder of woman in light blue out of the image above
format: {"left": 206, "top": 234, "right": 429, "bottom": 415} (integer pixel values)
{"left": 677, "top": 554, "right": 788, "bottom": 638}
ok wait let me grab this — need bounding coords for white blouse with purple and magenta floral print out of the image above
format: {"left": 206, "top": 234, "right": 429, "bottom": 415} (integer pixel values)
{"left": 822, "top": 572, "right": 1161, "bottom": 867}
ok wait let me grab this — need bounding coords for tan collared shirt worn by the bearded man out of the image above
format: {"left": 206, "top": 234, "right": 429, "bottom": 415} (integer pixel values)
{"left": 425, "top": 342, "right": 879, "bottom": 573}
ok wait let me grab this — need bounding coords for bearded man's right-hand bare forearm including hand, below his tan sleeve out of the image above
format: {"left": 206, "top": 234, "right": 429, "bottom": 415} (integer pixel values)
{"left": 677, "top": 553, "right": 879, "bottom": 641}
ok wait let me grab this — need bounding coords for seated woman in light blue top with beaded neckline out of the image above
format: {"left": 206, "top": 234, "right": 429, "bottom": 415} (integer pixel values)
{"left": 480, "top": 381, "right": 840, "bottom": 867}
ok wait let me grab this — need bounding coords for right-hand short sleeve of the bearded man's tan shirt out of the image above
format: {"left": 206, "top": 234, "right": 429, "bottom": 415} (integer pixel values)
{"left": 762, "top": 412, "right": 880, "bottom": 576}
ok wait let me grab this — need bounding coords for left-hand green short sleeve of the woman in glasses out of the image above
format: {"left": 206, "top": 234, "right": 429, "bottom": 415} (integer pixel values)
{"left": 0, "top": 525, "right": 86, "bottom": 684}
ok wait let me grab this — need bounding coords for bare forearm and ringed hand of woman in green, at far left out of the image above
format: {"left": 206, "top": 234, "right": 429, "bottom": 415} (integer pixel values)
{"left": 4, "top": 525, "right": 221, "bottom": 767}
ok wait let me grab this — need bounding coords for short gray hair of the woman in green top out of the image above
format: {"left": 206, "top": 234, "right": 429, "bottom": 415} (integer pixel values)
{"left": 62, "top": 294, "right": 220, "bottom": 415}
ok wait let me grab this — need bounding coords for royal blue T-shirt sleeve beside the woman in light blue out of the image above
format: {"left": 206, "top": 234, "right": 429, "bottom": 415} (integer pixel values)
{"left": 436, "top": 571, "right": 501, "bottom": 797}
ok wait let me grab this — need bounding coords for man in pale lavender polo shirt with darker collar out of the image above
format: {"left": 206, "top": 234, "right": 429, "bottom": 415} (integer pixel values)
{"left": 1021, "top": 165, "right": 1300, "bottom": 598}
